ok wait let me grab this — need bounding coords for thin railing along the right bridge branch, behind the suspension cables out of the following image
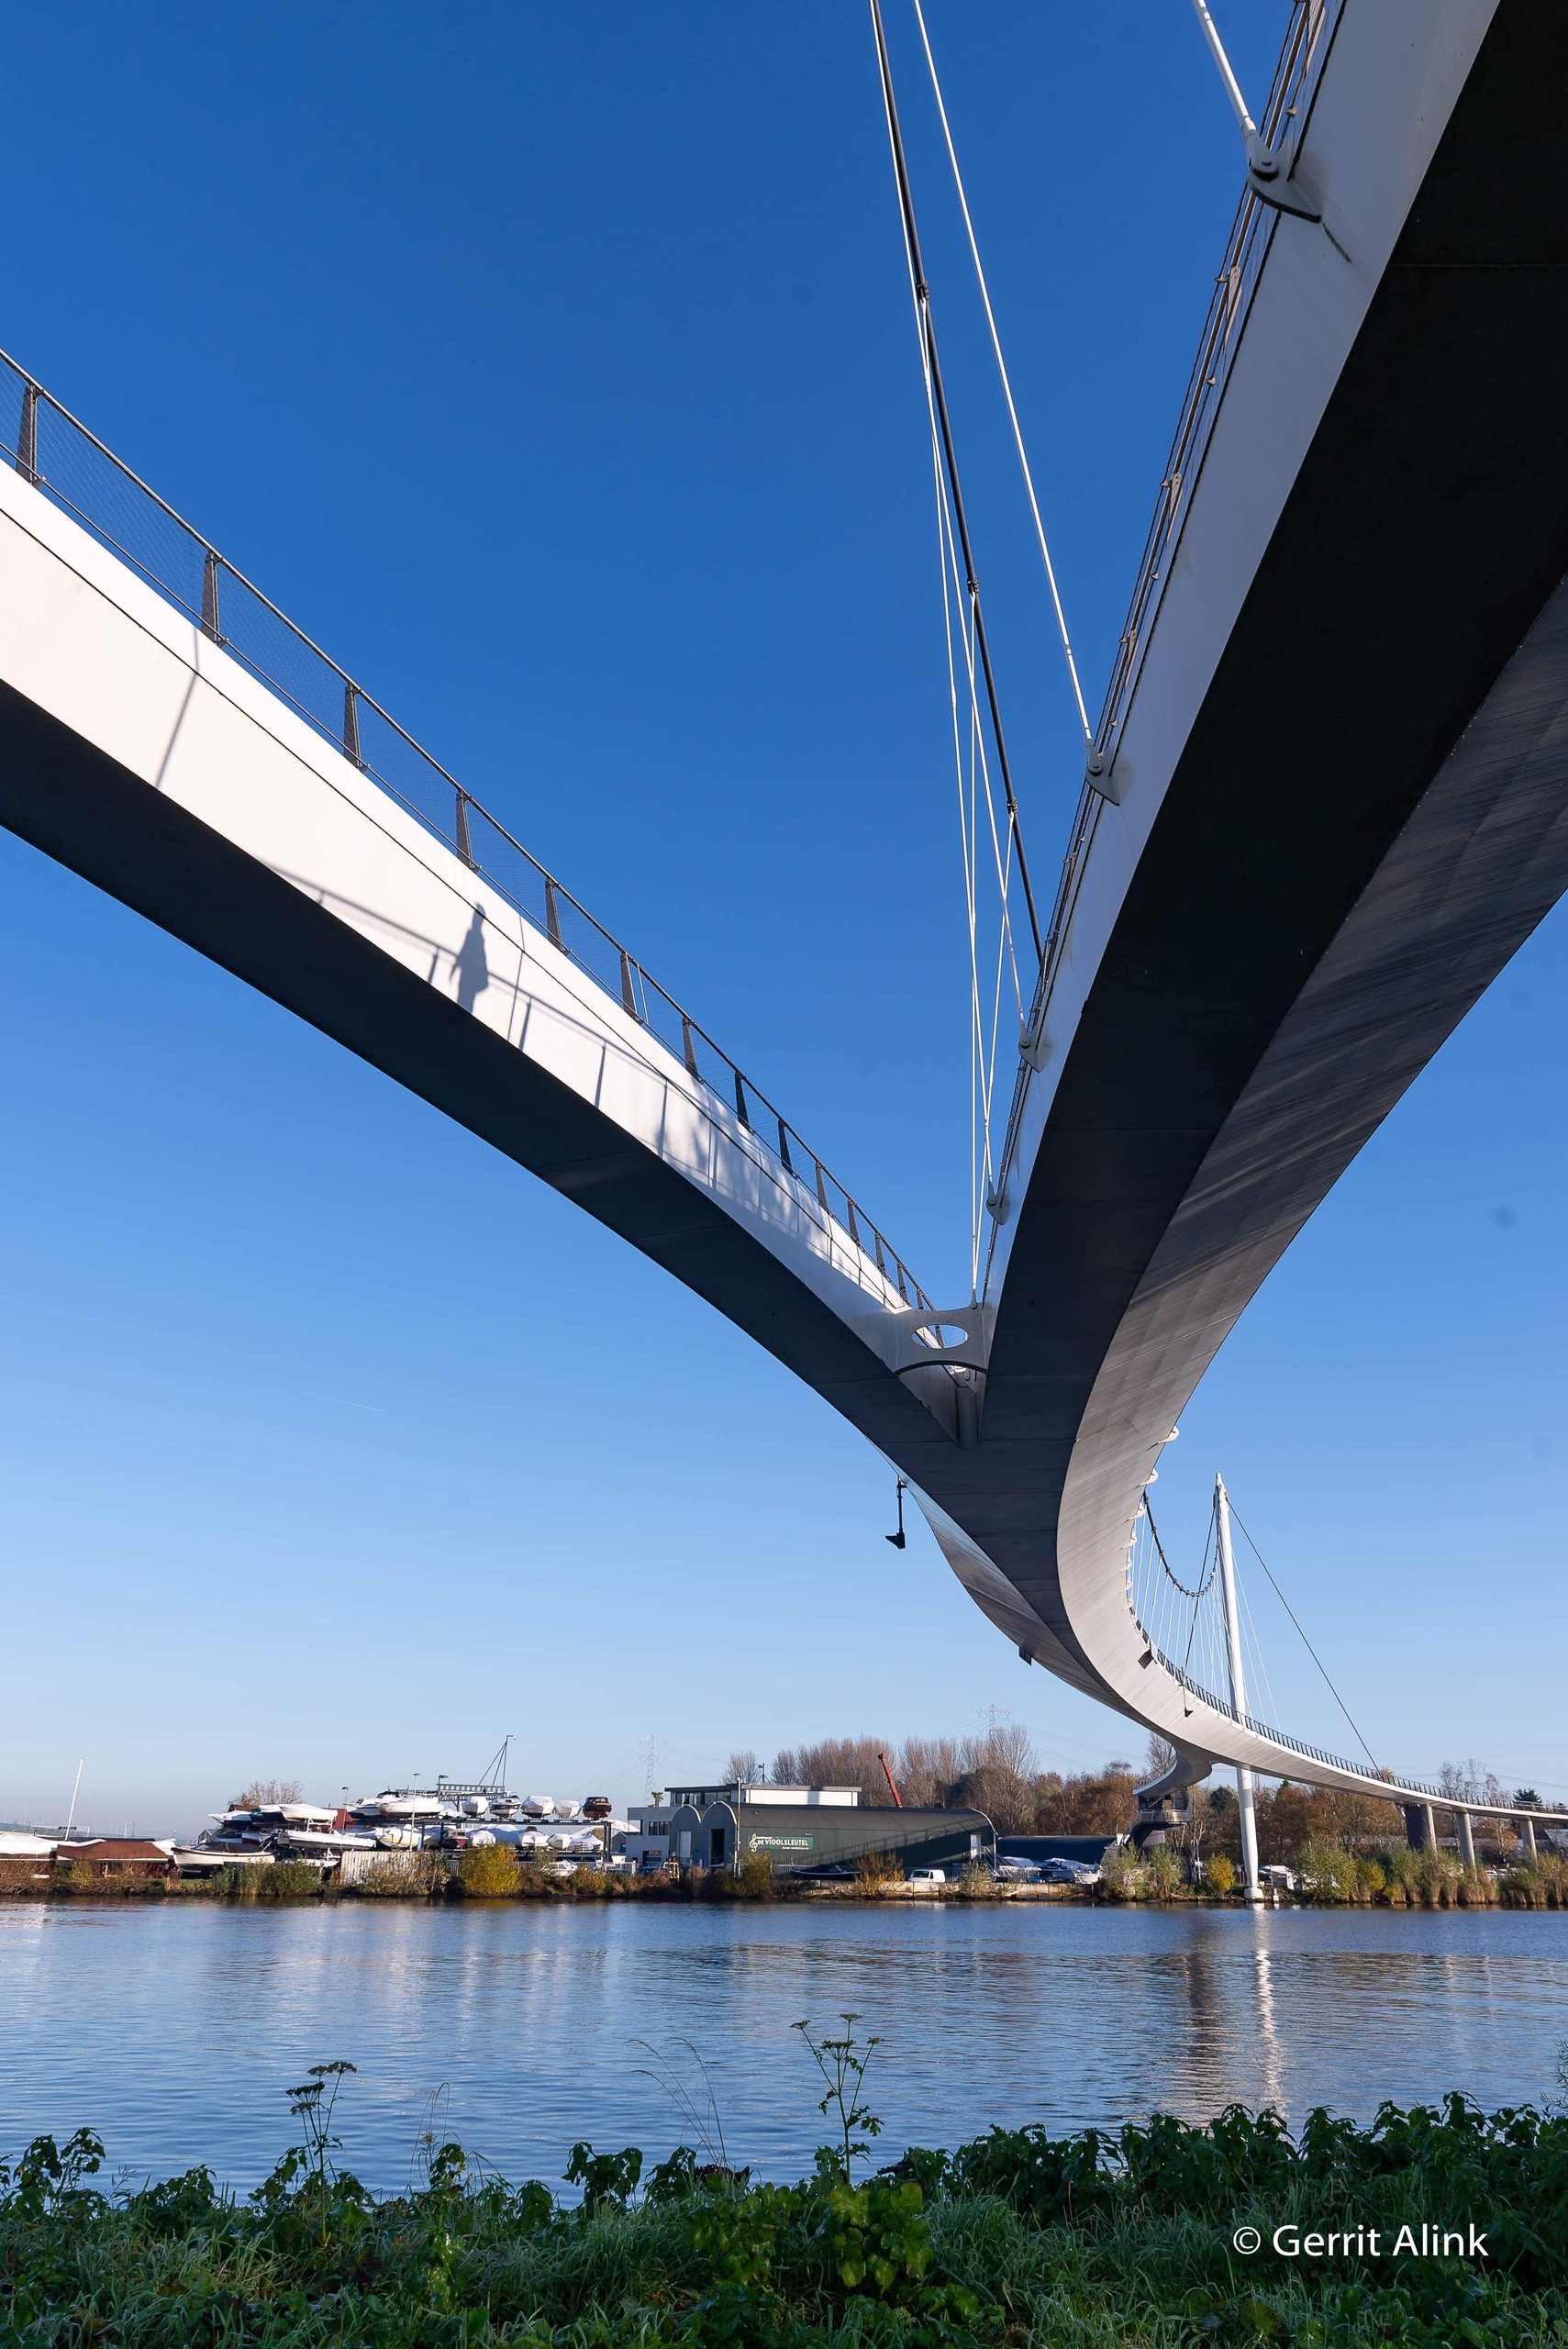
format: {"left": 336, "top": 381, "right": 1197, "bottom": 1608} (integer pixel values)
{"left": 993, "top": 0, "right": 1345, "bottom": 1286}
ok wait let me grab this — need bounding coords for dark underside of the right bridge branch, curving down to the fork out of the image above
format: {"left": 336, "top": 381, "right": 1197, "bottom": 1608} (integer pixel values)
{"left": 957, "top": 0, "right": 1568, "bottom": 1766}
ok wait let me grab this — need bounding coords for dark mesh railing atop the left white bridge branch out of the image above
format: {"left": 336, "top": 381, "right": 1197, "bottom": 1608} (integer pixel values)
{"left": 0, "top": 352, "right": 932, "bottom": 1310}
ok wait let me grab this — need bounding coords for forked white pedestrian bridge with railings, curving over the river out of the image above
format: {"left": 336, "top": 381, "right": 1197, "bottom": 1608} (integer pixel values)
{"left": 0, "top": 0, "right": 1568, "bottom": 1831}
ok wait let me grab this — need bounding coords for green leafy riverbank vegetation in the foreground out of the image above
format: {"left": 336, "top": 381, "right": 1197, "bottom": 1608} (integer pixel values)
{"left": 0, "top": 2086, "right": 1568, "bottom": 2349}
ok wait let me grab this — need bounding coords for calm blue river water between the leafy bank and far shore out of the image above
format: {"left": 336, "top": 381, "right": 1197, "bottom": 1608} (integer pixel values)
{"left": 0, "top": 1900, "right": 1568, "bottom": 2189}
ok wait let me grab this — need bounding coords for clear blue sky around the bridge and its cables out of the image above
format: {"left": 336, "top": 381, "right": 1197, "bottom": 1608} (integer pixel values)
{"left": 0, "top": 0, "right": 1568, "bottom": 1830}
